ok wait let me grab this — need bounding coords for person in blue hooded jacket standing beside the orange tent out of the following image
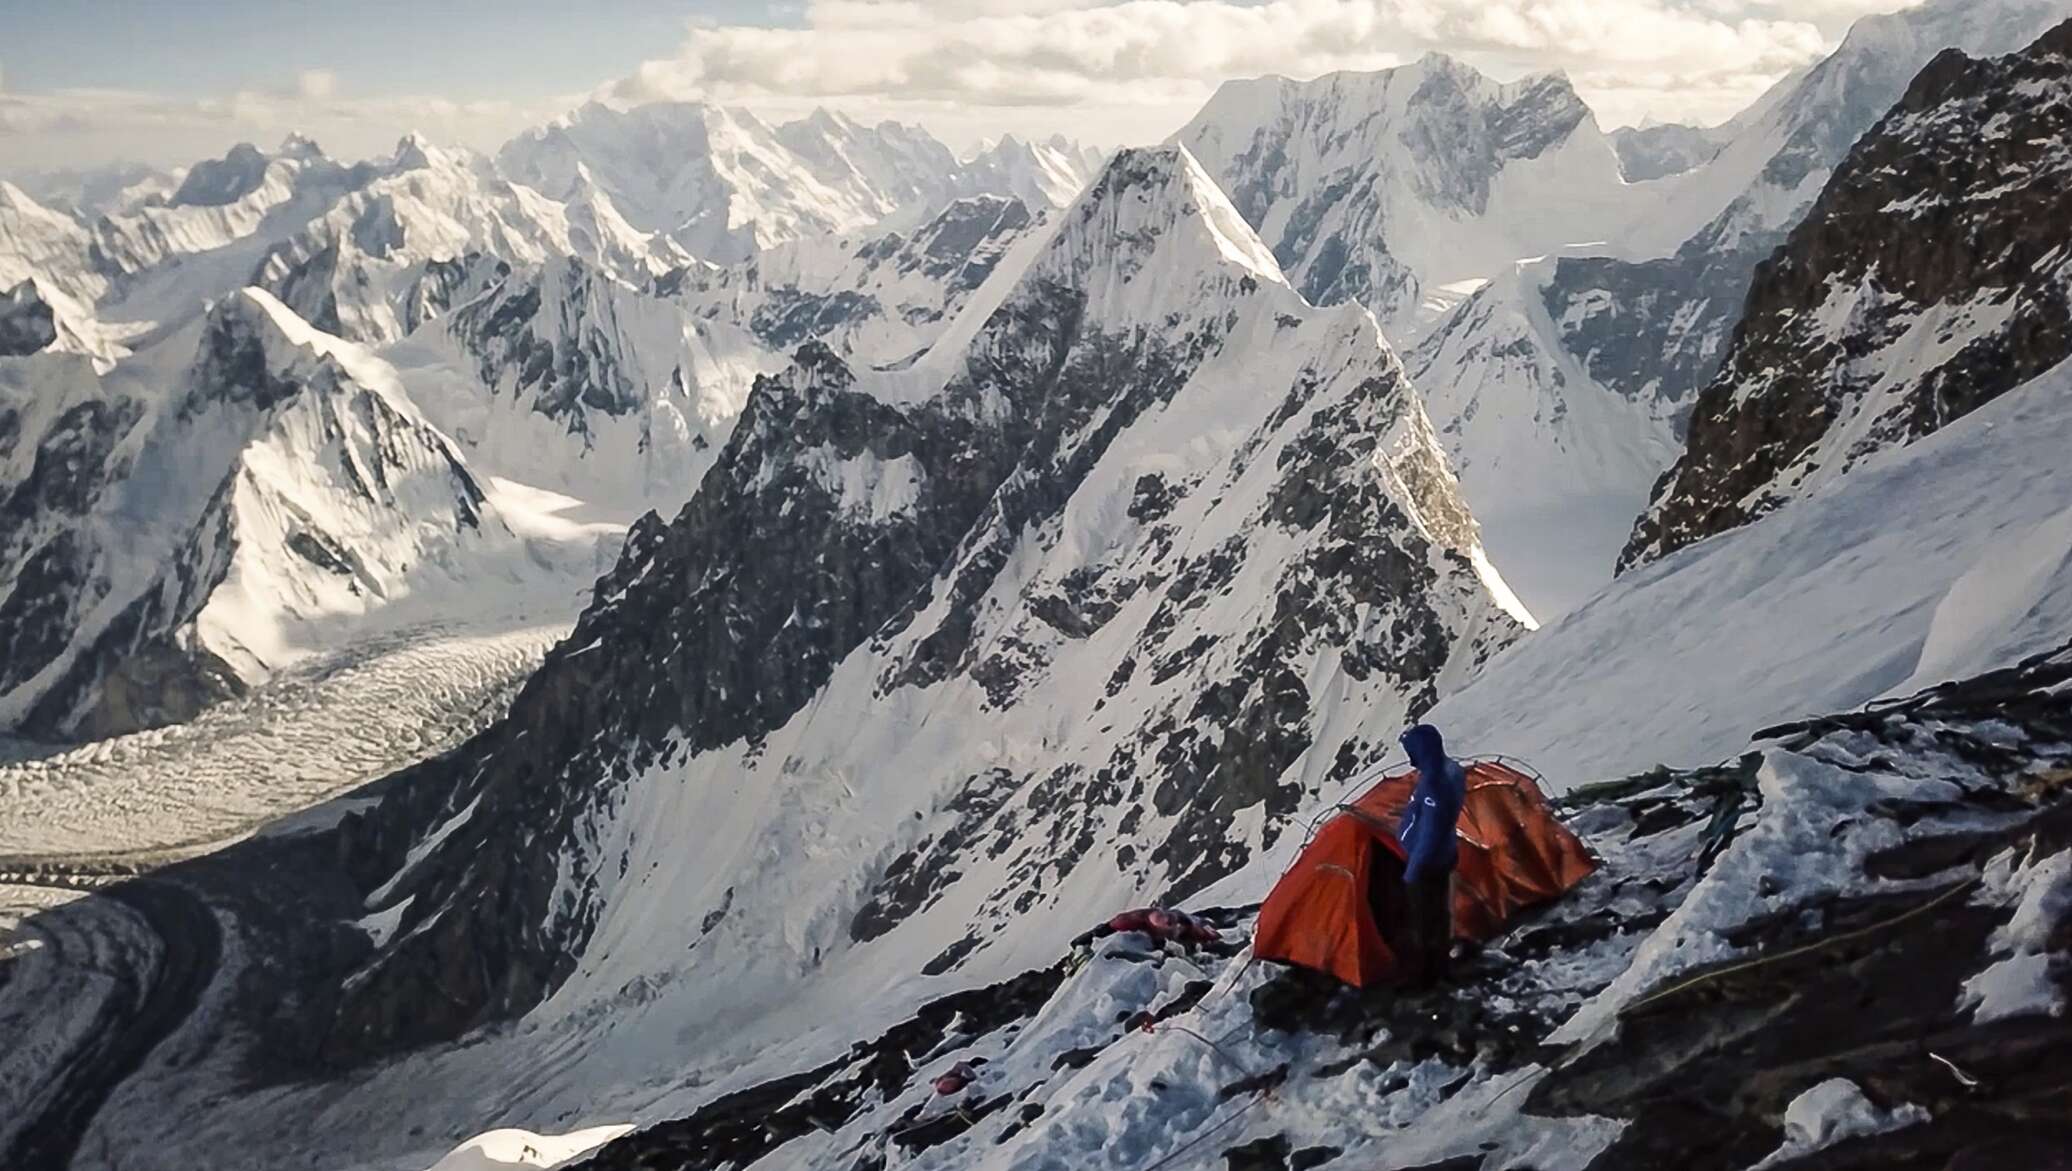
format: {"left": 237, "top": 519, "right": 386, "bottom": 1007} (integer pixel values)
{"left": 1397, "top": 723, "right": 1467, "bottom": 989}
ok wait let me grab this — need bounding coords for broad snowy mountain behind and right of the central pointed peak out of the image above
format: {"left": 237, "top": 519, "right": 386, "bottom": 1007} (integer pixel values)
{"left": 1175, "top": 54, "right": 1637, "bottom": 344}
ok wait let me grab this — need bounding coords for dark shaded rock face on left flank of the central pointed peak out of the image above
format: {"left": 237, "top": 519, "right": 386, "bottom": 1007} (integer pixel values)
{"left": 332, "top": 273, "right": 1127, "bottom": 1059}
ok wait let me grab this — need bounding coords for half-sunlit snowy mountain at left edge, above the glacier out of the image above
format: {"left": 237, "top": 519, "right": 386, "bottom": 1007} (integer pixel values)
{"left": 0, "top": 290, "right": 596, "bottom": 736}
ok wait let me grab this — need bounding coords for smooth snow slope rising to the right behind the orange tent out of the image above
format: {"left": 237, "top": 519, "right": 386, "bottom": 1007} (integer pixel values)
{"left": 1430, "top": 356, "right": 2072, "bottom": 788}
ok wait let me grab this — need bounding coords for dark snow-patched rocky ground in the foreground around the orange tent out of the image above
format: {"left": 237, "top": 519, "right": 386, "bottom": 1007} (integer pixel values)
{"left": 576, "top": 649, "right": 2072, "bottom": 1171}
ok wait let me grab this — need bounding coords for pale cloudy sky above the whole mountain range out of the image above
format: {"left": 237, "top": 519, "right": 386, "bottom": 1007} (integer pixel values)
{"left": 0, "top": 0, "right": 1912, "bottom": 174}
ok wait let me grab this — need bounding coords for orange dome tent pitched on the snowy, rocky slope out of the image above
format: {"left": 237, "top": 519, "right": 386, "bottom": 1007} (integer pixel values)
{"left": 1251, "top": 761, "right": 1598, "bottom": 987}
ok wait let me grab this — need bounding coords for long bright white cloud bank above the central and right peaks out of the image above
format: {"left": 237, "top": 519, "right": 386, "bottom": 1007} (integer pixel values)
{"left": 605, "top": 0, "right": 1864, "bottom": 132}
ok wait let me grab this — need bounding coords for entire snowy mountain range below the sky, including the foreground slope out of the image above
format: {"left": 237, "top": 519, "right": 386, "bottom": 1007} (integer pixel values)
{"left": 0, "top": 0, "right": 2072, "bottom": 1171}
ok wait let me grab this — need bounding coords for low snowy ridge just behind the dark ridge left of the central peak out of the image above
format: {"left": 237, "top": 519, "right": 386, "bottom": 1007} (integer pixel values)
{"left": 657, "top": 195, "right": 1036, "bottom": 365}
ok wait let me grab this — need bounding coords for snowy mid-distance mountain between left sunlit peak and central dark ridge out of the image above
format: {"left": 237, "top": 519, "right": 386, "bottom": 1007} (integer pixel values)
{"left": 383, "top": 259, "right": 783, "bottom": 509}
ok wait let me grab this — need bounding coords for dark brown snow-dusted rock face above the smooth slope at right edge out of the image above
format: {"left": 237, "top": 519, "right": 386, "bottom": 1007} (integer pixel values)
{"left": 1620, "top": 18, "right": 2072, "bottom": 568}
